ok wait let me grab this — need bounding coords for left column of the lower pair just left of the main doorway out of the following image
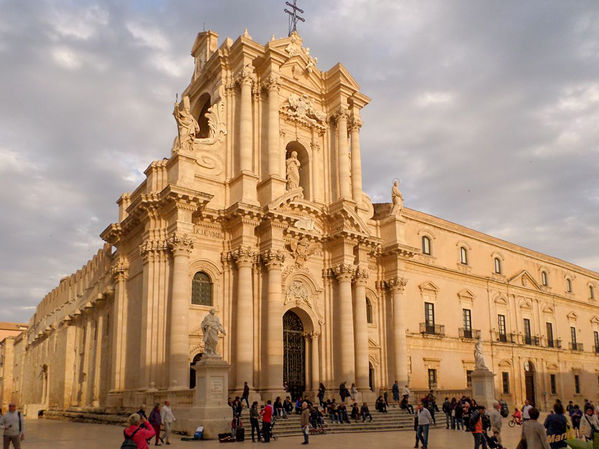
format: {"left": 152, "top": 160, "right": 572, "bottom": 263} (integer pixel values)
{"left": 231, "top": 247, "right": 255, "bottom": 390}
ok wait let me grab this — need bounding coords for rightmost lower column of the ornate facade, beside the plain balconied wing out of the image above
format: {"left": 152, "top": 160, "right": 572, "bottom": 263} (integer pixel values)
{"left": 388, "top": 278, "right": 408, "bottom": 385}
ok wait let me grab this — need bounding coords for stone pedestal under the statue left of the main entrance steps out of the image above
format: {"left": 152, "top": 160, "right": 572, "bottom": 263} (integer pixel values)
{"left": 176, "top": 356, "right": 232, "bottom": 439}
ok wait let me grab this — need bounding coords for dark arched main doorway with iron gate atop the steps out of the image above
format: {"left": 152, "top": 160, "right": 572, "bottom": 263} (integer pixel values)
{"left": 283, "top": 310, "right": 306, "bottom": 399}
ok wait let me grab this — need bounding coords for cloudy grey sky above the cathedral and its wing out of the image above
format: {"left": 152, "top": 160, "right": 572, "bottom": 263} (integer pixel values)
{"left": 0, "top": 0, "right": 599, "bottom": 321}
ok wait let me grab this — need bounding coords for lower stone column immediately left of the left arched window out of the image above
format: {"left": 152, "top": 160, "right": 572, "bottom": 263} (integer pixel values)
{"left": 167, "top": 233, "right": 193, "bottom": 390}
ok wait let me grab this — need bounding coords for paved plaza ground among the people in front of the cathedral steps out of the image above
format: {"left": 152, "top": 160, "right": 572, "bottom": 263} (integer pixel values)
{"left": 18, "top": 417, "right": 528, "bottom": 449}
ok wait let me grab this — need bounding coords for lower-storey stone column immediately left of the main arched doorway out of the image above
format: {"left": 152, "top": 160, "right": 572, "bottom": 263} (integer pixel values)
{"left": 261, "top": 249, "right": 285, "bottom": 391}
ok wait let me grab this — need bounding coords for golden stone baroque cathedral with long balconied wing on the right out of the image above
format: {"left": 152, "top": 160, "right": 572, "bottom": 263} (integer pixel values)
{"left": 0, "top": 27, "right": 599, "bottom": 411}
